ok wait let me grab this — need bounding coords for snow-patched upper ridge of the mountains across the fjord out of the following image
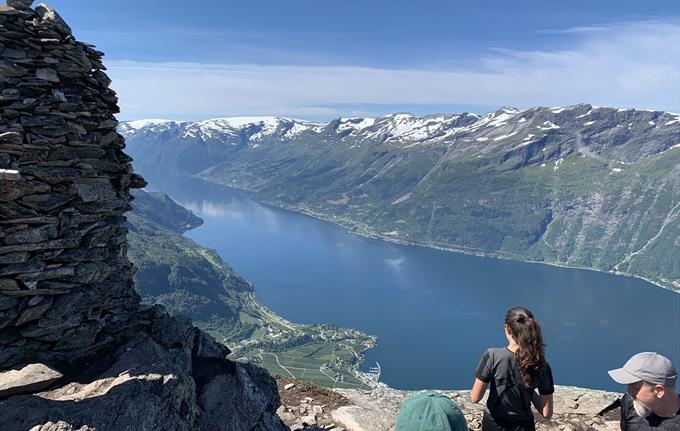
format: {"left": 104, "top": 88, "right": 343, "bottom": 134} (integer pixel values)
{"left": 118, "top": 104, "right": 680, "bottom": 148}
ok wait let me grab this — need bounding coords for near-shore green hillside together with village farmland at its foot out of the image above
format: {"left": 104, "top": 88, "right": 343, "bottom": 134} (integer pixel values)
{"left": 128, "top": 191, "right": 376, "bottom": 388}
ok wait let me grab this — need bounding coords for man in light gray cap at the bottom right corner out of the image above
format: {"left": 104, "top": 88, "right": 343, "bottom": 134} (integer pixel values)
{"left": 609, "top": 352, "right": 680, "bottom": 431}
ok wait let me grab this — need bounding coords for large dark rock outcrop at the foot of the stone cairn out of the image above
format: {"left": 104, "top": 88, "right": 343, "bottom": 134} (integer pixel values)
{"left": 0, "top": 312, "right": 288, "bottom": 431}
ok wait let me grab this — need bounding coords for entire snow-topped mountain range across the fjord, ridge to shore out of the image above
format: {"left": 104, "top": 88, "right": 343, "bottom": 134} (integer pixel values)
{"left": 120, "top": 105, "right": 680, "bottom": 289}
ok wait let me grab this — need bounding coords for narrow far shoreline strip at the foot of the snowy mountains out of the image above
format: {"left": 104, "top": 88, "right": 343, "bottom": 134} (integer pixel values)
{"left": 205, "top": 176, "right": 680, "bottom": 294}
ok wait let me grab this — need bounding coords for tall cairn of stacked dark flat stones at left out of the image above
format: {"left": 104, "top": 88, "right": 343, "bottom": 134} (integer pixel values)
{"left": 0, "top": 0, "right": 144, "bottom": 370}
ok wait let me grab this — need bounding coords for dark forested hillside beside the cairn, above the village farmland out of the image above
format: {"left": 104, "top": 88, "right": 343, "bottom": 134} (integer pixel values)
{"left": 128, "top": 191, "right": 258, "bottom": 341}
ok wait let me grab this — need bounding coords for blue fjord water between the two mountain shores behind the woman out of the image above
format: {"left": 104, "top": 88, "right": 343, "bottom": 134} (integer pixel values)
{"left": 147, "top": 175, "right": 680, "bottom": 390}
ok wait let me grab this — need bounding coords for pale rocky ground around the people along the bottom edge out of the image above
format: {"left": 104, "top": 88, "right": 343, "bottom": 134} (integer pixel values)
{"left": 277, "top": 377, "right": 621, "bottom": 431}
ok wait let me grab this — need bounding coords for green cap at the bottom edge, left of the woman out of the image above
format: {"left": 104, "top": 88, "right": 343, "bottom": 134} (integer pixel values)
{"left": 396, "top": 392, "right": 468, "bottom": 431}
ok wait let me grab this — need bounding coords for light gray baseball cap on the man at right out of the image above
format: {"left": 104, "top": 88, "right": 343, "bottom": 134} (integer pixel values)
{"left": 609, "top": 352, "right": 678, "bottom": 388}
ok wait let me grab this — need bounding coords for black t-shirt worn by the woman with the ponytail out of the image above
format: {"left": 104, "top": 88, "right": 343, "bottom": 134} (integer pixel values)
{"left": 475, "top": 347, "right": 555, "bottom": 421}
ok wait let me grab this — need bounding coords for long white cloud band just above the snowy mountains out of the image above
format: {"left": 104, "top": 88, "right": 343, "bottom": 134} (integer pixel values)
{"left": 107, "top": 22, "right": 680, "bottom": 119}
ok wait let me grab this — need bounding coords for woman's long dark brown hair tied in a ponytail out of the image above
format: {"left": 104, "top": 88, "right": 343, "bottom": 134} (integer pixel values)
{"left": 505, "top": 307, "right": 546, "bottom": 388}
